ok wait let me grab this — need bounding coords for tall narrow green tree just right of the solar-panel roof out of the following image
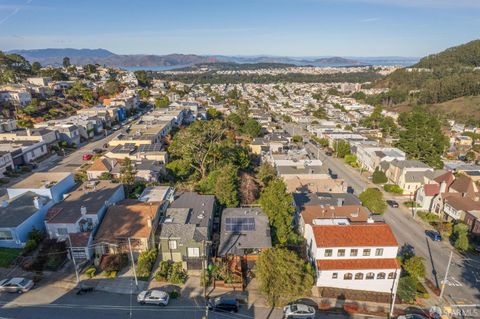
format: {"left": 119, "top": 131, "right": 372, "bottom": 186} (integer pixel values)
{"left": 258, "top": 178, "right": 296, "bottom": 245}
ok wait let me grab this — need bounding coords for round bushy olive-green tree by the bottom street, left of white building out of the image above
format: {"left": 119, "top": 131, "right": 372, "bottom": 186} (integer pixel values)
{"left": 254, "top": 248, "right": 314, "bottom": 306}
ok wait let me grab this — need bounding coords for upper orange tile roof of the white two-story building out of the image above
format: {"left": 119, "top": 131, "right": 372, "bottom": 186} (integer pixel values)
{"left": 312, "top": 223, "right": 398, "bottom": 247}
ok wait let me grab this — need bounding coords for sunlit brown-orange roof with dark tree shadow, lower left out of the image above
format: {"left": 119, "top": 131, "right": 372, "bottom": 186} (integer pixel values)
{"left": 95, "top": 200, "right": 162, "bottom": 243}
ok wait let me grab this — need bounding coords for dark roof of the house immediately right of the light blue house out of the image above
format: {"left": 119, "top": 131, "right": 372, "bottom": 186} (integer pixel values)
{"left": 45, "top": 181, "right": 123, "bottom": 224}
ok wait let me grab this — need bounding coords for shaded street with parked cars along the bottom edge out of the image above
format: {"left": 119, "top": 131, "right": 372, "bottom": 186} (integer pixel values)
{"left": 0, "top": 287, "right": 361, "bottom": 319}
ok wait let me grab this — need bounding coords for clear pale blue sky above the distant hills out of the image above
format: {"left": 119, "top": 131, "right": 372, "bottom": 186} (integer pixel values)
{"left": 0, "top": 0, "right": 480, "bottom": 56}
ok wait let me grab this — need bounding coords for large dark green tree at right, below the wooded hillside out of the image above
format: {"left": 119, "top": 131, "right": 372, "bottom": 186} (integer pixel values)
{"left": 396, "top": 106, "right": 448, "bottom": 168}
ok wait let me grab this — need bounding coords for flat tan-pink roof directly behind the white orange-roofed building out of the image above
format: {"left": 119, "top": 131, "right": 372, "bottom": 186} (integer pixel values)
{"left": 302, "top": 205, "right": 370, "bottom": 224}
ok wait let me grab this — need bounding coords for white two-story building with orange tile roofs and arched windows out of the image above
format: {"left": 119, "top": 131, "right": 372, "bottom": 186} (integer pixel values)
{"left": 304, "top": 219, "right": 401, "bottom": 301}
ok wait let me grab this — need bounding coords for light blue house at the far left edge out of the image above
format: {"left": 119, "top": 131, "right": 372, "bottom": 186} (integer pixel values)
{"left": 0, "top": 191, "right": 54, "bottom": 248}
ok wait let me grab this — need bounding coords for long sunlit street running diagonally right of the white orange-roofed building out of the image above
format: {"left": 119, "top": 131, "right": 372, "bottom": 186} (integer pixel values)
{"left": 286, "top": 124, "right": 480, "bottom": 307}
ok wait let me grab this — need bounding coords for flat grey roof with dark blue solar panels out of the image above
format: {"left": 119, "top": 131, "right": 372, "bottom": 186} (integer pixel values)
{"left": 218, "top": 207, "right": 272, "bottom": 256}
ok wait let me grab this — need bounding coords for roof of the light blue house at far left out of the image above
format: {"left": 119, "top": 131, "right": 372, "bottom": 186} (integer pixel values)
{"left": 0, "top": 192, "right": 50, "bottom": 228}
